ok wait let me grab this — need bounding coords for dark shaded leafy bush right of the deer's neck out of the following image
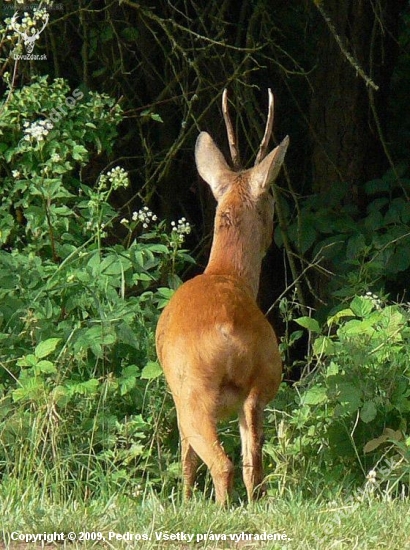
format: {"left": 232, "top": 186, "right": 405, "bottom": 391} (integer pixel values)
{"left": 276, "top": 172, "right": 410, "bottom": 301}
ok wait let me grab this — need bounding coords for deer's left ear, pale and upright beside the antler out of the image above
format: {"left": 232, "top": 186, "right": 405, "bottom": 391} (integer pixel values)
{"left": 195, "top": 132, "right": 232, "bottom": 200}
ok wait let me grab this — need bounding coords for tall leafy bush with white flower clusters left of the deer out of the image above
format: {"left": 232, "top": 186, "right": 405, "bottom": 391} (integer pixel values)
{"left": 0, "top": 77, "right": 190, "bottom": 498}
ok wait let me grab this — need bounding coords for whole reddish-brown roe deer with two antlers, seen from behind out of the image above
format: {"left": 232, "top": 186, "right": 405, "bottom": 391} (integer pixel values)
{"left": 156, "top": 90, "right": 289, "bottom": 504}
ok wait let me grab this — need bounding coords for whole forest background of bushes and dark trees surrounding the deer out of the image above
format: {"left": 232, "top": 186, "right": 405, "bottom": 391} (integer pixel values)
{"left": 0, "top": 0, "right": 410, "bottom": 540}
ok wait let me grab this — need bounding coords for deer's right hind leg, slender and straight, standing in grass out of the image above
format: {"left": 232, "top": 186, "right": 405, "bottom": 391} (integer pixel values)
{"left": 239, "top": 397, "right": 263, "bottom": 501}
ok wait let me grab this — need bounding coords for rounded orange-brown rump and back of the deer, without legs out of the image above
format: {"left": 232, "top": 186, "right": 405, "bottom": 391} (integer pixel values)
{"left": 157, "top": 274, "right": 281, "bottom": 421}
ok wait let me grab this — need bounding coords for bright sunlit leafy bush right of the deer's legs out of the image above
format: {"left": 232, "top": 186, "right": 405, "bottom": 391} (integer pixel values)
{"left": 267, "top": 293, "right": 410, "bottom": 500}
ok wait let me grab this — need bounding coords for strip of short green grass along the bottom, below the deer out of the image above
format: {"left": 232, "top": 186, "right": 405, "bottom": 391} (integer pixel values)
{"left": 0, "top": 483, "right": 410, "bottom": 550}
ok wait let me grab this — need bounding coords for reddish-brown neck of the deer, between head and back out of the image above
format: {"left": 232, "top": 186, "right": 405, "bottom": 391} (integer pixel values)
{"left": 205, "top": 204, "right": 262, "bottom": 298}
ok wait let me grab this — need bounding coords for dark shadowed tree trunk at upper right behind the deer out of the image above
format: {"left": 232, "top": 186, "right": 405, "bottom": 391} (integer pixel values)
{"left": 310, "top": 0, "right": 406, "bottom": 206}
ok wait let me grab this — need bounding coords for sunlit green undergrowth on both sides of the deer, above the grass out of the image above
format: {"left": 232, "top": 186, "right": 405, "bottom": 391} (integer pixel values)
{"left": 0, "top": 72, "right": 410, "bottom": 516}
